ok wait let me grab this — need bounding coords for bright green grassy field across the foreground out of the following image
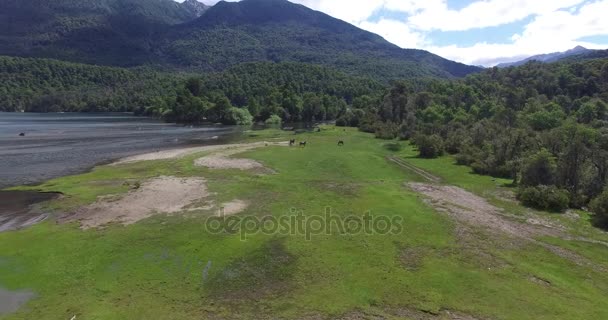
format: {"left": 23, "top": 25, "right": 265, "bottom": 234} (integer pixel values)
{"left": 0, "top": 127, "right": 608, "bottom": 320}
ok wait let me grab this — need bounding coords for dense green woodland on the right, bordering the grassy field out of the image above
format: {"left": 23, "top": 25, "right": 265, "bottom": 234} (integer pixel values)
{"left": 356, "top": 59, "right": 608, "bottom": 220}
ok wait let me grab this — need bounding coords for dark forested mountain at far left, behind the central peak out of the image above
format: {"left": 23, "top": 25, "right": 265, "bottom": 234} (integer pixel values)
{"left": 0, "top": 0, "right": 207, "bottom": 66}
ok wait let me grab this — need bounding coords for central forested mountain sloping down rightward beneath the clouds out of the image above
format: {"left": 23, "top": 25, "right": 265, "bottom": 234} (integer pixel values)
{"left": 163, "top": 0, "right": 479, "bottom": 79}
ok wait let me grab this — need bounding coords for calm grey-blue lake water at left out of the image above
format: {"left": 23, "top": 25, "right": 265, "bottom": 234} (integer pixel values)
{"left": 0, "top": 112, "right": 241, "bottom": 189}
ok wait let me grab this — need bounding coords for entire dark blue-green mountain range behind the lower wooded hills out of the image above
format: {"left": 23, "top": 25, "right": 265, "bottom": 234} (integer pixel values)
{"left": 0, "top": 0, "right": 480, "bottom": 81}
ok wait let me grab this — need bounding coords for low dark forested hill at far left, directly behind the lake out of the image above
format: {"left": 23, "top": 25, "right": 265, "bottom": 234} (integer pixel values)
{"left": 0, "top": 56, "right": 186, "bottom": 112}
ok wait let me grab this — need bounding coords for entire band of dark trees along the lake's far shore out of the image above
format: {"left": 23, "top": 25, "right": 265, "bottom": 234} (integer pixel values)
{"left": 0, "top": 56, "right": 384, "bottom": 124}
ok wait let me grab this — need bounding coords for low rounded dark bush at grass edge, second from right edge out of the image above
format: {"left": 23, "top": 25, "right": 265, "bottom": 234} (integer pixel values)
{"left": 517, "top": 186, "right": 570, "bottom": 212}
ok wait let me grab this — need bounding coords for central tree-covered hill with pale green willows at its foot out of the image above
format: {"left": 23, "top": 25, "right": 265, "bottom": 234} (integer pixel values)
{"left": 146, "top": 62, "right": 383, "bottom": 124}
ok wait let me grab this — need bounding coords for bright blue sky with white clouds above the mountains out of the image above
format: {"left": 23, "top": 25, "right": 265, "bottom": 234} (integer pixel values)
{"left": 177, "top": 0, "right": 608, "bottom": 67}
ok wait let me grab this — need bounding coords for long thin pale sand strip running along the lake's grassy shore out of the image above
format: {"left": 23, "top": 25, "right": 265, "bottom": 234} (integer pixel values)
{"left": 112, "top": 142, "right": 289, "bottom": 165}
